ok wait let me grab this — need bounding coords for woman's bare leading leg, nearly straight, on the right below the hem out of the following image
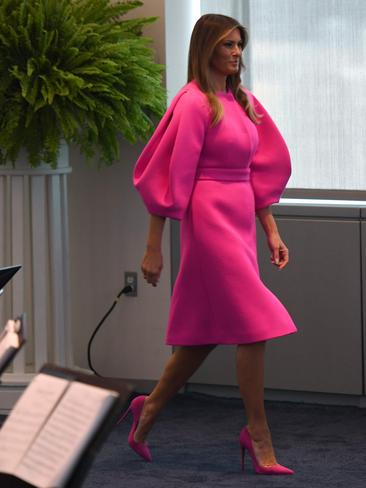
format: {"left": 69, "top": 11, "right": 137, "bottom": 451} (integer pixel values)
{"left": 236, "top": 341, "right": 276, "bottom": 466}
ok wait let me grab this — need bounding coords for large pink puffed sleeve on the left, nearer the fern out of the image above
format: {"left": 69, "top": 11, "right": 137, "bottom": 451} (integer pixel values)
{"left": 133, "top": 90, "right": 210, "bottom": 220}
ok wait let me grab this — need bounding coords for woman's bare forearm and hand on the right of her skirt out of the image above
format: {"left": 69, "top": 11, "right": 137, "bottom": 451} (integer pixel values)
{"left": 256, "top": 207, "right": 289, "bottom": 269}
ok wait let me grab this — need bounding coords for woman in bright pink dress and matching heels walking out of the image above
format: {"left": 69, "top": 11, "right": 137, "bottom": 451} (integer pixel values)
{"left": 121, "top": 14, "right": 297, "bottom": 474}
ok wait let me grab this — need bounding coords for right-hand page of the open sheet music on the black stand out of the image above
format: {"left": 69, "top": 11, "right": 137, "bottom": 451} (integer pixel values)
{"left": 15, "top": 381, "right": 118, "bottom": 488}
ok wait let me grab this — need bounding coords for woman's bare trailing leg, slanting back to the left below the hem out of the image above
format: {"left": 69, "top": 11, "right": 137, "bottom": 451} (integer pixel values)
{"left": 134, "top": 345, "right": 216, "bottom": 442}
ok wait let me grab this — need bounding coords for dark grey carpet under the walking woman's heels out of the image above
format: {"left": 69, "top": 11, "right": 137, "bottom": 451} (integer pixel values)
{"left": 83, "top": 394, "right": 366, "bottom": 488}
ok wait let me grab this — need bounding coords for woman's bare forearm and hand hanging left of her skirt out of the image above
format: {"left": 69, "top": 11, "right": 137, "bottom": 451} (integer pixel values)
{"left": 141, "top": 215, "right": 166, "bottom": 286}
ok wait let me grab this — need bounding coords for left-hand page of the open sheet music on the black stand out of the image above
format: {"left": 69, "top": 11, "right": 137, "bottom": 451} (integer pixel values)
{"left": 0, "top": 373, "right": 70, "bottom": 474}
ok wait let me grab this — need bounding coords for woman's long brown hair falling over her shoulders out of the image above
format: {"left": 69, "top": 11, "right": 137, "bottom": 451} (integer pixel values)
{"left": 188, "top": 14, "right": 261, "bottom": 126}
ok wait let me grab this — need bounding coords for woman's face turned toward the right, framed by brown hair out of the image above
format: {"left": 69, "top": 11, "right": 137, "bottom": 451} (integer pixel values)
{"left": 211, "top": 29, "right": 243, "bottom": 76}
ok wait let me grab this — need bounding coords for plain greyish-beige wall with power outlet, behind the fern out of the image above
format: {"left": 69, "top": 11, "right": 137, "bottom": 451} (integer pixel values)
{"left": 69, "top": 0, "right": 171, "bottom": 380}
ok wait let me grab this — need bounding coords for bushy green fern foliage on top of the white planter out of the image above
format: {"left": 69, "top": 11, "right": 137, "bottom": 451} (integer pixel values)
{"left": 0, "top": 0, "right": 165, "bottom": 167}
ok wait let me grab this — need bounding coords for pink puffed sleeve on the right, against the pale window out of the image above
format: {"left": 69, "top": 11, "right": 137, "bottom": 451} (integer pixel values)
{"left": 245, "top": 90, "right": 291, "bottom": 210}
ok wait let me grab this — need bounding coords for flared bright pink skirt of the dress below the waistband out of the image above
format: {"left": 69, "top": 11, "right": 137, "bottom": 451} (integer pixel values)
{"left": 166, "top": 180, "right": 297, "bottom": 345}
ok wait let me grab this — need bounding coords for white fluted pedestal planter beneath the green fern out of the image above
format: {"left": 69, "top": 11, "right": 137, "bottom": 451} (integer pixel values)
{"left": 0, "top": 144, "right": 73, "bottom": 388}
